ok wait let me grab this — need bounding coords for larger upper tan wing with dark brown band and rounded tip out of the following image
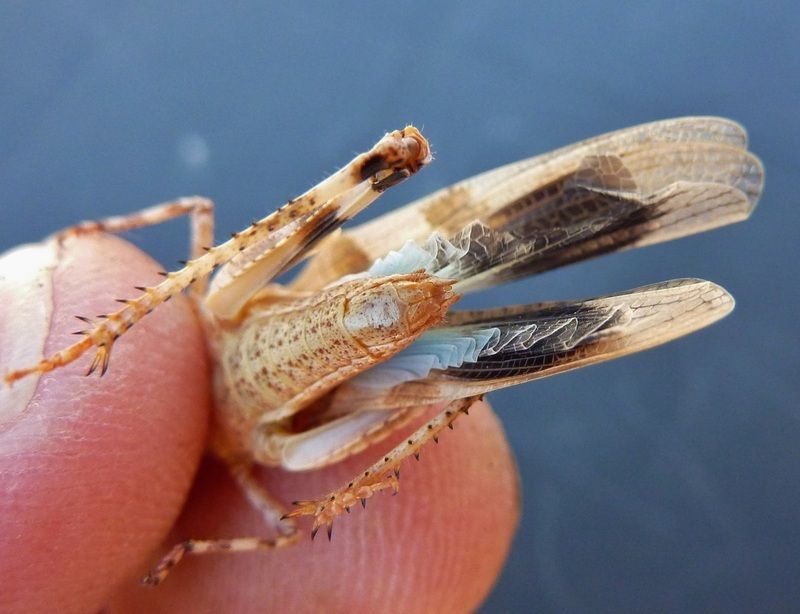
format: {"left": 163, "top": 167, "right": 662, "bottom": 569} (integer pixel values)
{"left": 296, "top": 117, "right": 763, "bottom": 291}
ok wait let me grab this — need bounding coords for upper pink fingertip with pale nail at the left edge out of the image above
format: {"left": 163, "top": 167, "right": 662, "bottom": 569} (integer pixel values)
{"left": 0, "top": 236, "right": 208, "bottom": 612}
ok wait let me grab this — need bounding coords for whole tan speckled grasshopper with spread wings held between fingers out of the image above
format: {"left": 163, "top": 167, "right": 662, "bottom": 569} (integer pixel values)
{"left": 5, "top": 117, "right": 763, "bottom": 584}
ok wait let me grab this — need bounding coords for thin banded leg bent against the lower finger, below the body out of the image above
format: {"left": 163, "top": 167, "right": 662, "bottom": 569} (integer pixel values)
{"left": 142, "top": 463, "right": 300, "bottom": 586}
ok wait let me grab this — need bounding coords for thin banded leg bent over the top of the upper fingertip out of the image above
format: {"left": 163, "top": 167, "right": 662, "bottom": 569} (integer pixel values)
{"left": 55, "top": 196, "right": 214, "bottom": 296}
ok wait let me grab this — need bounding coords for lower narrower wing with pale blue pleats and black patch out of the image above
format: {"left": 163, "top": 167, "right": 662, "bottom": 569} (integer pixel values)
{"left": 331, "top": 279, "right": 734, "bottom": 411}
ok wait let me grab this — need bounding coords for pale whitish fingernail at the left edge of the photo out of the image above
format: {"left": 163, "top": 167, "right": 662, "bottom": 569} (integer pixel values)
{"left": 0, "top": 241, "right": 58, "bottom": 425}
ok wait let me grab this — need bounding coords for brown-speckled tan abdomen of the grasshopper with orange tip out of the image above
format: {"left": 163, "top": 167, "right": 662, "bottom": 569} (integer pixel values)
{"left": 209, "top": 273, "right": 456, "bottom": 464}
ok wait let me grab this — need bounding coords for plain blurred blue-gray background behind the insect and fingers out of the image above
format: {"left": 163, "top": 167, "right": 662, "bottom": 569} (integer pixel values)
{"left": 0, "top": 2, "right": 800, "bottom": 612}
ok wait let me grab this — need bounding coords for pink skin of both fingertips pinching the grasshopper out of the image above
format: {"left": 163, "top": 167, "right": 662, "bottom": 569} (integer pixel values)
{"left": 0, "top": 235, "right": 519, "bottom": 612}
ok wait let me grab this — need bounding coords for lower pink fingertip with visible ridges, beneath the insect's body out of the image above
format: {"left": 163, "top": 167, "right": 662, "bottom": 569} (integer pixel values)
{"left": 112, "top": 404, "right": 519, "bottom": 612}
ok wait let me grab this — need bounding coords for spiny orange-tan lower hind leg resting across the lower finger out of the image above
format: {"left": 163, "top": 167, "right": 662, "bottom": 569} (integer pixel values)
{"left": 286, "top": 395, "right": 482, "bottom": 539}
